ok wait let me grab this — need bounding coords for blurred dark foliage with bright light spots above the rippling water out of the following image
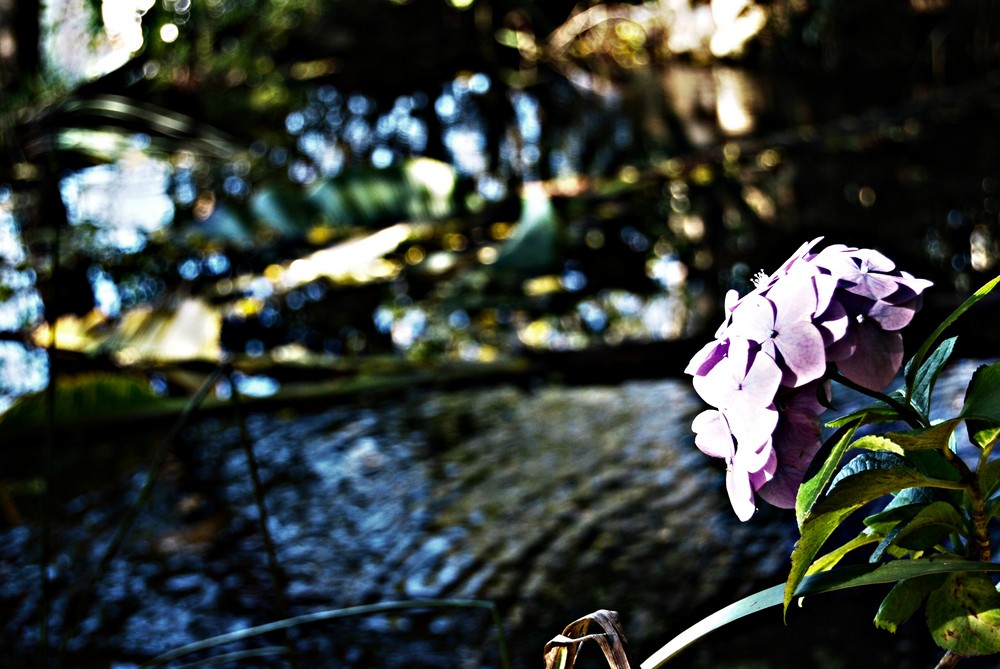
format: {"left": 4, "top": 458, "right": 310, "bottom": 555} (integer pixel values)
{"left": 0, "top": 0, "right": 1000, "bottom": 410}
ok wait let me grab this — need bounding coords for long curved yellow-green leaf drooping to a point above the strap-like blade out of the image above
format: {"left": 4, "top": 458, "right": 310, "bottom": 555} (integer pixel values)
{"left": 785, "top": 467, "right": 962, "bottom": 611}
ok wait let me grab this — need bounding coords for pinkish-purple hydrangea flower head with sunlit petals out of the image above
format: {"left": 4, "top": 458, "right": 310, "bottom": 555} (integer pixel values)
{"left": 685, "top": 237, "right": 932, "bottom": 521}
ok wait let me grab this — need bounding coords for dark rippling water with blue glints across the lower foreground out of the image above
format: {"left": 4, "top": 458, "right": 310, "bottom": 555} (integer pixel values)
{"left": 0, "top": 363, "right": 989, "bottom": 667}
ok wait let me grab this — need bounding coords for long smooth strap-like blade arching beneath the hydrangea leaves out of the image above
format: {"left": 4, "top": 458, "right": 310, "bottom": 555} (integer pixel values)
{"left": 640, "top": 558, "right": 1000, "bottom": 669}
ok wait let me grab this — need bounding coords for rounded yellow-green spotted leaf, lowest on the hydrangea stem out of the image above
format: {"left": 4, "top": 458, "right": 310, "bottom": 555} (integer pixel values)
{"left": 927, "top": 574, "right": 1000, "bottom": 656}
